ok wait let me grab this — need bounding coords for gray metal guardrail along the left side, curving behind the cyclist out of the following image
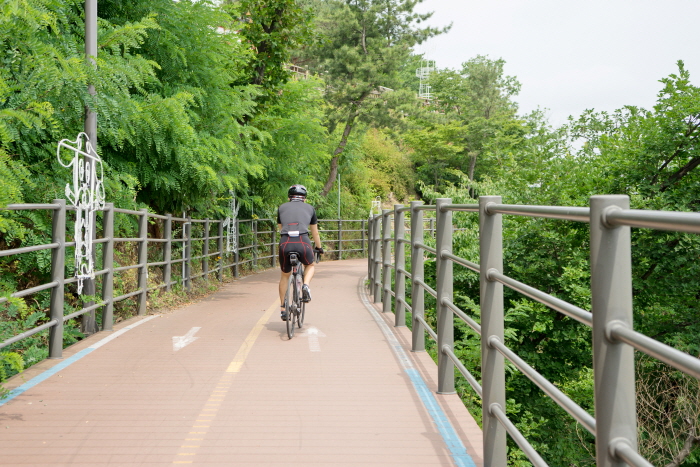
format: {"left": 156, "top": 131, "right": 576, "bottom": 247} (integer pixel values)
{"left": 0, "top": 199, "right": 368, "bottom": 358}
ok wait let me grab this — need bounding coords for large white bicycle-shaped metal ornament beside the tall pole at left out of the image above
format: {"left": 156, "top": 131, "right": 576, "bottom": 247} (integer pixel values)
{"left": 56, "top": 133, "right": 105, "bottom": 294}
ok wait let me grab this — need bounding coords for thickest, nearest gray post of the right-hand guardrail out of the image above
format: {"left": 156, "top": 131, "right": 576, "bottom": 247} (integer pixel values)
{"left": 590, "top": 195, "right": 637, "bottom": 467}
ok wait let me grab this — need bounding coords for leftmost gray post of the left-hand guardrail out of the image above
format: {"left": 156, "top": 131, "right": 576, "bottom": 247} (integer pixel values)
{"left": 49, "top": 199, "right": 66, "bottom": 358}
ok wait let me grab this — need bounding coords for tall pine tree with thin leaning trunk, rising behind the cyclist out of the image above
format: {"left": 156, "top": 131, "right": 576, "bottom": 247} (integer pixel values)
{"left": 304, "top": 0, "right": 447, "bottom": 196}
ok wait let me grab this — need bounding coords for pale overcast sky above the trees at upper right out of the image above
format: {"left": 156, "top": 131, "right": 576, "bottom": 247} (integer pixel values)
{"left": 415, "top": 0, "right": 700, "bottom": 126}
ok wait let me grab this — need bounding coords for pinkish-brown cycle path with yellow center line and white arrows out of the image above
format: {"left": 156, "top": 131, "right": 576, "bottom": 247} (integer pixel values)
{"left": 0, "top": 260, "right": 483, "bottom": 467}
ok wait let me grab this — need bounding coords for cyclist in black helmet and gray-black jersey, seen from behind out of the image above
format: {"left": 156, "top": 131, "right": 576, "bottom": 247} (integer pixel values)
{"left": 277, "top": 185, "right": 323, "bottom": 321}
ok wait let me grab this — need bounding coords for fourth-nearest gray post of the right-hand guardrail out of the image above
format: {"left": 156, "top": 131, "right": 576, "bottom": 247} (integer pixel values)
{"left": 411, "top": 201, "right": 425, "bottom": 352}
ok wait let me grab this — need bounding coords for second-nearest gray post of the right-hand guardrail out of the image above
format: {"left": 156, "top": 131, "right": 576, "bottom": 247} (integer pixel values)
{"left": 479, "top": 196, "right": 507, "bottom": 467}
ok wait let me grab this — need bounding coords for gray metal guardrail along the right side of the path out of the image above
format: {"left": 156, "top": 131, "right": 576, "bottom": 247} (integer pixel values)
{"left": 368, "top": 195, "right": 700, "bottom": 467}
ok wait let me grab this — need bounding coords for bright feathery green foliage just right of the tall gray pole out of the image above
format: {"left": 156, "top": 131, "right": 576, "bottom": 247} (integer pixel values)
{"left": 98, "top": 0, "right": 265, "bottom": 213}
